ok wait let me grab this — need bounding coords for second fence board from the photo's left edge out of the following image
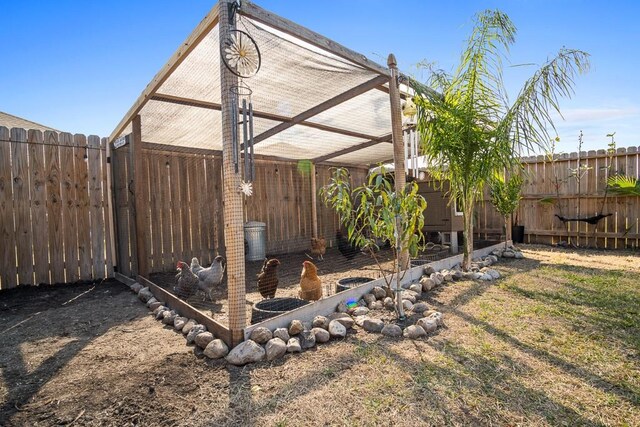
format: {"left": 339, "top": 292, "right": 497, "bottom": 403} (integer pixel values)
{"left": 11, "top": 128, "right": 33, "bottom": 284}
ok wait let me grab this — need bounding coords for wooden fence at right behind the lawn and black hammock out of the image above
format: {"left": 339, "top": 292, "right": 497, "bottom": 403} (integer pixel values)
{"left": 476, "top": 147, "right": 640, "bottom": 249}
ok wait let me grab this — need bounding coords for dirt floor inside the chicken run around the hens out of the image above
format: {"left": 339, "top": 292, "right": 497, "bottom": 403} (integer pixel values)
{"left": 150, "top": 248, "right": 450, "bottom": 325}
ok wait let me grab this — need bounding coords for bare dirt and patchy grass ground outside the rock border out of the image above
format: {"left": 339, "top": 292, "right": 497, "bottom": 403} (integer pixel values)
{"left": 0, "top": 246, "right": 640, "bottom": 426}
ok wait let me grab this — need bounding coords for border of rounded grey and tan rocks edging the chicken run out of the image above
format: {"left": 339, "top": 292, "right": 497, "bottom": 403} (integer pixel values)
{"left": 124, "top": 245, "right": 524, "bottom": 366}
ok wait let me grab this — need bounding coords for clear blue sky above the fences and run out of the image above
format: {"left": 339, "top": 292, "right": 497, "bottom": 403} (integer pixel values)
{"left": 0, "top": 0, "right": 640, "bottom": 151}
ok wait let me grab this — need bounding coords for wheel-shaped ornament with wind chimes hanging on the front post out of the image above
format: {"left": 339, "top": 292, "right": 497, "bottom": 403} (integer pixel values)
{"left": 220, "top": 2, "right": 262, "bottom": 196}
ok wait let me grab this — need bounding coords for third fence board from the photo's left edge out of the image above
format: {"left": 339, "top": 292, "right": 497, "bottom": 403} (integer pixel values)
{"left": 27, "top": 130, "right": 50, "bottom": 283}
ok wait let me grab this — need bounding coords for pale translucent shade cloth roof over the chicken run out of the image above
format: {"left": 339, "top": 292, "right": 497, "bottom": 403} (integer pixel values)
{"left": 111, "top": 1, "right": 412, "bottom": 166}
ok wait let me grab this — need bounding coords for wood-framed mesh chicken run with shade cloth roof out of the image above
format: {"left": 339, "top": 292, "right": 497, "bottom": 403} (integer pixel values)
{"left": 109, "top": 0, "right": 424, "bottom": 342}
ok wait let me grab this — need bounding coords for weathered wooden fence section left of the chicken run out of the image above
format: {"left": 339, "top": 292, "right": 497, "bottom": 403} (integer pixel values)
{"left": 0, "top": 126, "right": 113, "bottom": 289}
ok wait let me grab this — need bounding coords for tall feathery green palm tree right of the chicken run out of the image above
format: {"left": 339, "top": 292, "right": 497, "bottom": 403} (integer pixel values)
{"left": 410, "top": 10, "right": 589, "bottom": 270}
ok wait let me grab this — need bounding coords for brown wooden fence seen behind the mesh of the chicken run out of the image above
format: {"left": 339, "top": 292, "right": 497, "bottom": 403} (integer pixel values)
{"left": 112, "top": 143, "right": 367, "bottom": 275}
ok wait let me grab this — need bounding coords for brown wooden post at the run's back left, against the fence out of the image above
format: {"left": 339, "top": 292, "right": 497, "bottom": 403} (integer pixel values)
{"left": 129, "top": 114, "right": 149, "bottom": 277}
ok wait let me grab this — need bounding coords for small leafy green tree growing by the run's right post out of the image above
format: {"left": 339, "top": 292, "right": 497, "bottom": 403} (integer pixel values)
{"left": 320, "top": 167, "right": 427, "bottom": 318}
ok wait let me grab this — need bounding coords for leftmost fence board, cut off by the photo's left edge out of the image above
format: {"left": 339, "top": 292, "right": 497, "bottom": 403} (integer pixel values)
{"left": 0, "top": 126, "right": 18, "bottom": 289}
